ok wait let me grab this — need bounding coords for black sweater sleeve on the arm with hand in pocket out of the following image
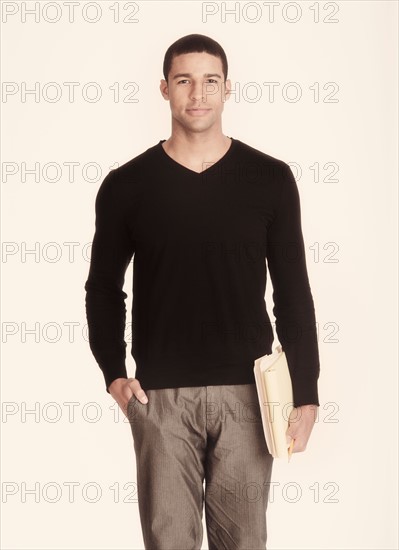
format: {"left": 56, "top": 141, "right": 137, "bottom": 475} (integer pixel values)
{"left": 84, "top": 170, "right": 134, "bottom": 393}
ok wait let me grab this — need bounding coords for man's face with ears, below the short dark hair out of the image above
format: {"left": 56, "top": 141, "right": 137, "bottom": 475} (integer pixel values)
{"left": 160, "top": 52, "right": 230, "bottom": 136}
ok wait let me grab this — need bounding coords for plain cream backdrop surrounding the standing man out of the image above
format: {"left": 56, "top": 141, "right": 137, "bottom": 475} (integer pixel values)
{"left": 1, "top": 1, "right": 398, "bottom": 550}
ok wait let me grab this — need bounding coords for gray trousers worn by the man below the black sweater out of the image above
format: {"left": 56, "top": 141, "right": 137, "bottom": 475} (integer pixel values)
{"left": 127, "top": 384, "right": 273, "bottom": 550}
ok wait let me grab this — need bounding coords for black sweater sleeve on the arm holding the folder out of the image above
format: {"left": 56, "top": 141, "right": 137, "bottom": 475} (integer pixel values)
{"left": 266, "top": 164, "right": 320, "bottom": 407}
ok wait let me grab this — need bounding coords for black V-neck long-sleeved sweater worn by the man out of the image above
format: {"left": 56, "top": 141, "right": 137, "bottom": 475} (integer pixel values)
{"left": 85, "top": 138, "right": 320, "bottom": 406}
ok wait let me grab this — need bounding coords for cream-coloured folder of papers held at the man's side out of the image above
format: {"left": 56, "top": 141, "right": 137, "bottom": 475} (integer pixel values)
{"left": 254, "top": 346, "right": 294, "bottom": 460}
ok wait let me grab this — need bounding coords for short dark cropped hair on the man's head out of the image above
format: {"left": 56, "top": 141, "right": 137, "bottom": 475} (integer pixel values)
{"left": 163, "top": 34, "right": 228, "bottom": 82}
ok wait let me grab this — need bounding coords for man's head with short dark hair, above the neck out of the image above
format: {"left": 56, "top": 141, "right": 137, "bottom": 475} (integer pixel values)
{"left": 160, "top": 34, "right": 230, "bottom": 136}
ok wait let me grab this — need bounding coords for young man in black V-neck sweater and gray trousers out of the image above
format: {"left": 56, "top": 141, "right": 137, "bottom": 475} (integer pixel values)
{"left": 85, "top": 34, "right": 319, "bottom": 550}
